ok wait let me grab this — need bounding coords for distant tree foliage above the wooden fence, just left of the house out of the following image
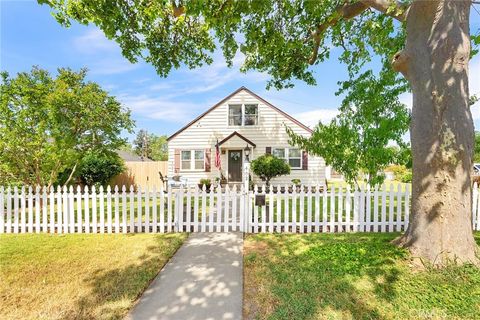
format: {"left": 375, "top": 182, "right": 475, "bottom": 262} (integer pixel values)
{"left": 133, "top": 129, "right": 168, "bottom": 161}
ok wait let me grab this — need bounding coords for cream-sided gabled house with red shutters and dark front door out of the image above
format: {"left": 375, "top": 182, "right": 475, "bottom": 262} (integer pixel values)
{"left": 168, "top": 87, "right": 325, "bottom": 185}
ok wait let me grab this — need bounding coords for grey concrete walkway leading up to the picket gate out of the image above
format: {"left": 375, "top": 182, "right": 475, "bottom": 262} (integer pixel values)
{"left": 127, "top": 233, "right": 243, "bottom": 320}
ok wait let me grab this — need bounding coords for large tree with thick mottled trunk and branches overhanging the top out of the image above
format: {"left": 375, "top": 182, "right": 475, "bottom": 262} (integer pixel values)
{"left": 39, "top": 0, "right": 478, "bottom": 265}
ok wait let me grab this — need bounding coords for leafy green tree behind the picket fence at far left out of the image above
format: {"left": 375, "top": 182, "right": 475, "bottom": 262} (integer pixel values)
{"left": 0, "top": 67, "right": 133, "bottom": 186}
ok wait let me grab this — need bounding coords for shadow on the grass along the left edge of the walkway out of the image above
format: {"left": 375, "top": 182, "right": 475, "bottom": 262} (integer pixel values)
{"left": 62, "top": 234, "right": 181, "bottom": 320}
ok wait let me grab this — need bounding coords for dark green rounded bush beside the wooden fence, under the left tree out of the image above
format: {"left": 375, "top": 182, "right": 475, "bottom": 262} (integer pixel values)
{"left": 79, "top": 153, "right": 125, "bottom": 186}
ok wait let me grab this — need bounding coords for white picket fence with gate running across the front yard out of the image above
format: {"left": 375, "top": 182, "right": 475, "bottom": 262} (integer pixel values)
{"left": 0, "top": 185, "right": 480, "bottom": 233}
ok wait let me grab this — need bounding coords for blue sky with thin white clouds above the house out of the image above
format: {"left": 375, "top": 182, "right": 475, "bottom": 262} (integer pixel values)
{"left": 0, "top": 0, "right": 480, "bottom": 139}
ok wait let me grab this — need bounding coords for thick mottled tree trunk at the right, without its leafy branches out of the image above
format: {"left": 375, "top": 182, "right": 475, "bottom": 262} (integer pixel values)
{"left": 393, "top": 1, "right": 477, "bottom": 266}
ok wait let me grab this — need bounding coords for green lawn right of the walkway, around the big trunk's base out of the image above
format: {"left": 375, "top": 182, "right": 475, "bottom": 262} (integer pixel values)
{"left": 244, "top": 233, "right": 480, "bottom": 319}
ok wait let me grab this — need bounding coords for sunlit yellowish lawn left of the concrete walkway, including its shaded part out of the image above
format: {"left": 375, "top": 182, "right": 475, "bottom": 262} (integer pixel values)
{"left": 0, "top": 233, "right": 187, "bottom": 319}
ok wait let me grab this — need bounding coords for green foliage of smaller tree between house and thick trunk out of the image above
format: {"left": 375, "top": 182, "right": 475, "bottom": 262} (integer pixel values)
{"left": 287, "top": 71, "right": 410, "bottom": 185}
